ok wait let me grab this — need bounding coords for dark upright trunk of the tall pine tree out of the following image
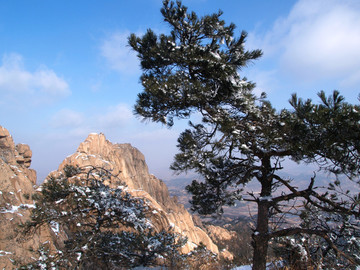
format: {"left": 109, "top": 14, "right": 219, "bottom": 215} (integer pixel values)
{"left": 253, "top": 158, "right": 272, "bottom": 270}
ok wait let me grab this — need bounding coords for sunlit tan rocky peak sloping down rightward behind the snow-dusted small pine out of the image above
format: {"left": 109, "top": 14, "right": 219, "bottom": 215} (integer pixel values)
{"left": 59, "top": 133, "right": 218, "bottom": 253}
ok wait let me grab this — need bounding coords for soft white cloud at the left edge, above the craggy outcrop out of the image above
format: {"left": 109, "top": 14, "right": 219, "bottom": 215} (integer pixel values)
{"left": 0, "top": 53, "right": 70, "bottom": 103}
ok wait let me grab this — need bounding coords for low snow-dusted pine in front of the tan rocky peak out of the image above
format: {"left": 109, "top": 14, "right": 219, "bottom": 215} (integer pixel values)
{"left": 22, "top": 166, "right": 186, "bottom": 269}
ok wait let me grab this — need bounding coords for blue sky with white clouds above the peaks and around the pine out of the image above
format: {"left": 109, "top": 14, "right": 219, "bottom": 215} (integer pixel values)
{"left": 0, "top": 0, "right": 360, "bottom": 182}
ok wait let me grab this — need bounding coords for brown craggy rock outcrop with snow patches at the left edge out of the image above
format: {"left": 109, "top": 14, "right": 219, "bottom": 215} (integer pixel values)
{"left": 0, "top": 126, "right": 52, "bottom": 269}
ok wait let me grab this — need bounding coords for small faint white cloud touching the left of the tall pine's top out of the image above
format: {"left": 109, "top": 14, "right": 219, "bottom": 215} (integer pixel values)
{"left": 100, "top": 32, "right": 140, "bottom": 75}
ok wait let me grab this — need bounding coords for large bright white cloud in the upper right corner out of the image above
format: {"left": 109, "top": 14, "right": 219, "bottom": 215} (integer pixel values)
{"left": 249, "top": 0, "right": 360, "bottom": 85}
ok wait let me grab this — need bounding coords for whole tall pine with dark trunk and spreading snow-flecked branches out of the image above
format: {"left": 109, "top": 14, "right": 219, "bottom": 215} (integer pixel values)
{"left": 129, "top": 0, "right": 360, "bottom": 269}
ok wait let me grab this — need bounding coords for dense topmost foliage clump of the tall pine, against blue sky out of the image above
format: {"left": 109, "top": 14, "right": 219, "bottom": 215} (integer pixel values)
{"left": 129, "top": 1, "right": 261, "bottom": 126}
